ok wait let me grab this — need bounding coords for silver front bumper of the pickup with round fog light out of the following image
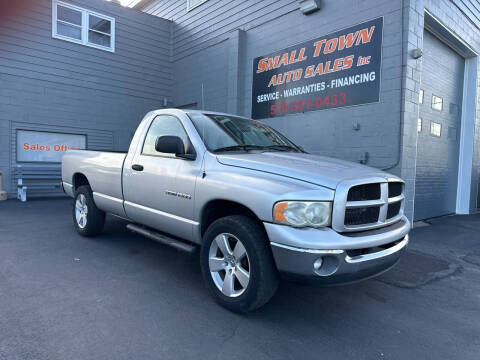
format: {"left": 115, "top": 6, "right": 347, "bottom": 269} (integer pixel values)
{"left": 265, "top": 218, "right": 410, "bottom": 285}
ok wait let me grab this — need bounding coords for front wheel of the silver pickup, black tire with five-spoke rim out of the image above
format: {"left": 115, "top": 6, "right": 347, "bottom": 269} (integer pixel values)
{"left": 200, "top": 215, "right": 279, "bottom": 313}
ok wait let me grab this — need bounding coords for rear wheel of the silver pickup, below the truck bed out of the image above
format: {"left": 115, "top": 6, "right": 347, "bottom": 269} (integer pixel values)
{"left": 73, "top": 185, "right": 105, "bottom": 237}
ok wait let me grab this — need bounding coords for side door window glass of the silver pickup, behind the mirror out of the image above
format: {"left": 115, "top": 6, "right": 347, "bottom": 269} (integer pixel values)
{"left": 142, "top": 115, "right": 187, "bottom": 155}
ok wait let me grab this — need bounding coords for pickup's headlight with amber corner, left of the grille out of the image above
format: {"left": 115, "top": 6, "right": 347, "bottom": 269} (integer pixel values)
{"left": 273, "top": 201, "right": 332, "bottom": 227}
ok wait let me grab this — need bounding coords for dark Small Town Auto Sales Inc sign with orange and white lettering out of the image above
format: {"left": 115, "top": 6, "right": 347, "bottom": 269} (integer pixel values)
{"left": 252, "top": 17, "right": 383, "bottom": 119}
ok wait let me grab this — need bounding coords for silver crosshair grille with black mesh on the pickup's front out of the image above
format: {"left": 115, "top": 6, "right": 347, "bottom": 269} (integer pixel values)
{"left": 332, "top": 179, "right": 404, "bottom": 232}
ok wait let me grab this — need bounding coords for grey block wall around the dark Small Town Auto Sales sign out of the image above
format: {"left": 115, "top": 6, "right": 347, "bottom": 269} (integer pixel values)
{"left": 144, "top": 0, "right": 402, "bottom": 170}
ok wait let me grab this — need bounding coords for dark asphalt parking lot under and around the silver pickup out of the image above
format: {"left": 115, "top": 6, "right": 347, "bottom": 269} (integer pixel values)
{"left": 0, "top": 199, "right": 480, "bottom": 360}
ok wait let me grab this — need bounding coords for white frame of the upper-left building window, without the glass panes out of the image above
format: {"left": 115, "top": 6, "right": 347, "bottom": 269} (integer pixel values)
{"left": 52, "top": 0, "right": 115, "bottom": 53}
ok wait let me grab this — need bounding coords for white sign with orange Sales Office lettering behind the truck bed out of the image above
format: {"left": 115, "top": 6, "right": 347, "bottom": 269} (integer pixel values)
{"left": 17, "top": 130, "right": 87, "bottom": 163}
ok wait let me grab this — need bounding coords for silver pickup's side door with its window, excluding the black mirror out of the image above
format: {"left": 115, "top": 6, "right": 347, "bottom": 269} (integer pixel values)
{"left": 123, "top": 115, "right": 201, "bottom": 239}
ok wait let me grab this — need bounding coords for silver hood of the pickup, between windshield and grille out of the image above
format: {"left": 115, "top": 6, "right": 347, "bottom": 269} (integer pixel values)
{"left": 217, "top": 152, "right": 395, "bottom": 189}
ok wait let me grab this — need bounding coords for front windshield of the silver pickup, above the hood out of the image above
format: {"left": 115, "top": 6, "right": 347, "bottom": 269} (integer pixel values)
{"left": 188, "top": 113, "right": 303, "bottom": 152}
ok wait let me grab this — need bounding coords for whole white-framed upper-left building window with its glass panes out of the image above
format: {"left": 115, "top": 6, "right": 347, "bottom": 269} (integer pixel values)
{"left": 52, "top": 0, "right": 115, "bottom": 52}
